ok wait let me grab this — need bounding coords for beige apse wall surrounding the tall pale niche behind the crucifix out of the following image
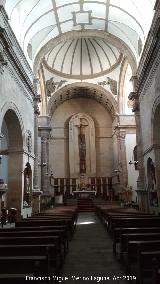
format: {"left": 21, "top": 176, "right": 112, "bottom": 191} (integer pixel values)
{"left": 49, "top": 98, "right": 112, "bottom": 177}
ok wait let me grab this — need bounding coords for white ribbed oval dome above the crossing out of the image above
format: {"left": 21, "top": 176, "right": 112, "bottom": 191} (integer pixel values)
{"left": 43, "top": 37, "right": 122, "bottom": 79}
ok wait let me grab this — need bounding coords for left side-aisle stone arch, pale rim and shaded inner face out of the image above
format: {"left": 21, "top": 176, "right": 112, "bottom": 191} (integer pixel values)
{"left": 0, "top": 108, "right": 23, "bottom": 210}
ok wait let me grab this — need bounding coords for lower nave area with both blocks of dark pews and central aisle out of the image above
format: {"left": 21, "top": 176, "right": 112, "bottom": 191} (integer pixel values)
{"left": 0, "top": 203, "right": 160, "bottom": 284}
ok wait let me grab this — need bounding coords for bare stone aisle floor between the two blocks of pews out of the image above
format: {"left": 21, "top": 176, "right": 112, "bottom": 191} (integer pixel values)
{"left": 62, "top": 213, "right": 136, "bottom": 284}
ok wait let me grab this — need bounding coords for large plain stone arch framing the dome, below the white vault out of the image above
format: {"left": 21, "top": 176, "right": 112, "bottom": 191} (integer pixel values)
{"left": 33, "top": 30, "right": 137, "bottom": 76}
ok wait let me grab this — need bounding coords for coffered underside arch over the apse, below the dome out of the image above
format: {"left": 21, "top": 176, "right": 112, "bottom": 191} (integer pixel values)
{"left": 47, "top": 82, "right": 118, "bottom": 120}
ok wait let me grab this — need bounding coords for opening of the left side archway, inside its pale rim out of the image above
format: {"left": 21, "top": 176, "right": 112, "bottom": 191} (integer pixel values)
{"left": 0, "top": 109, "right": 23, "bottom": 210}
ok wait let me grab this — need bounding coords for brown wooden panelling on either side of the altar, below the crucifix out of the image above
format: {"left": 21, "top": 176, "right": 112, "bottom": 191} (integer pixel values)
{"left": 50, "top": 177, "right": 114, "bottom": 199}
